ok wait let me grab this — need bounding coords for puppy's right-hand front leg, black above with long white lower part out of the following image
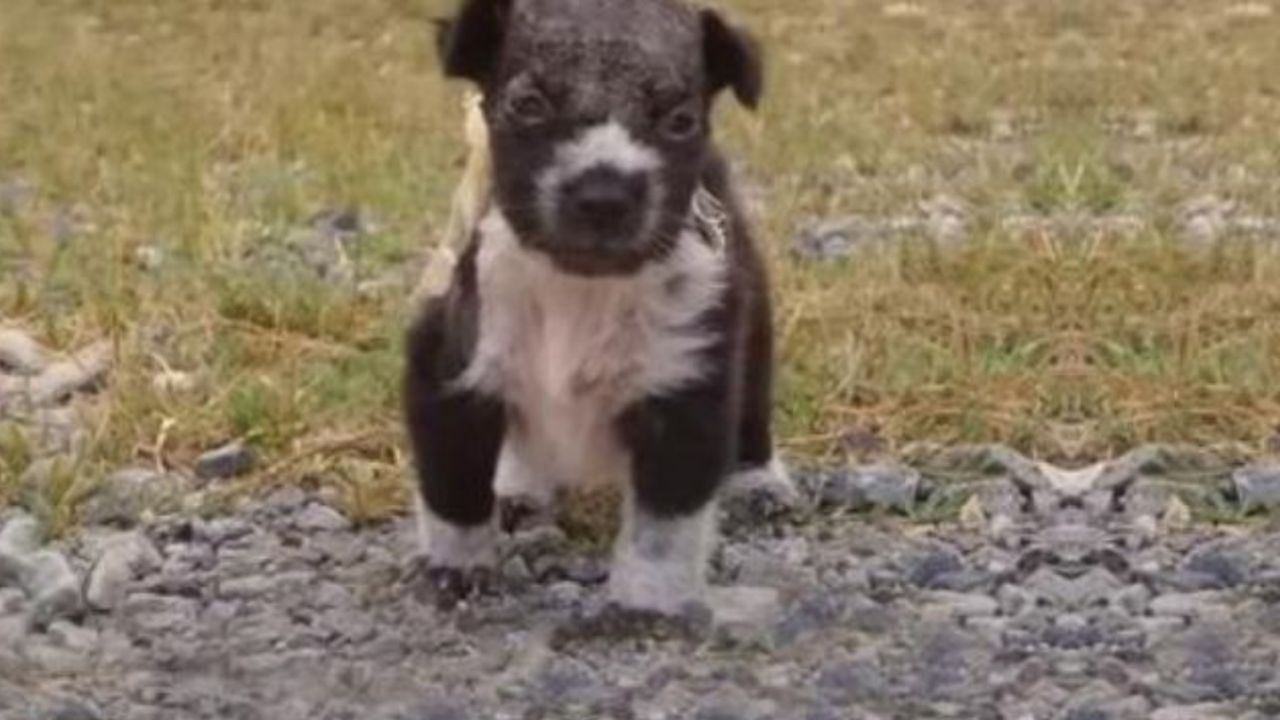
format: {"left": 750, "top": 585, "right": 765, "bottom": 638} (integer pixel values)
{"left": 609, "top": 372, "right": 736, "bottom": 615}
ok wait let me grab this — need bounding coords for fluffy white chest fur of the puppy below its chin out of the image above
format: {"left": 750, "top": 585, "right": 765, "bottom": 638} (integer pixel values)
{"left": 460, "top": 210, "right": 724, "bottom": 486}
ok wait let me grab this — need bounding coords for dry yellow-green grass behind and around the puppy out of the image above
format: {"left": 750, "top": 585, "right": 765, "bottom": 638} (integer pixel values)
{"left": 0, "top": 0, "right": 1280, "bottom": 516}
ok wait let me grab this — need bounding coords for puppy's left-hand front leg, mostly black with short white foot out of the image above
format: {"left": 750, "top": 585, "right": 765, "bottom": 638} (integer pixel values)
{"left": 404, "top": 299, "right": 504, "bottom": 605}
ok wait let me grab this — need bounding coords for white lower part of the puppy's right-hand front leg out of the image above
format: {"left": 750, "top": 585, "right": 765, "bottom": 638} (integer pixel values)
{"left": 608, "top": 484, "right": 716, "bottom": 607}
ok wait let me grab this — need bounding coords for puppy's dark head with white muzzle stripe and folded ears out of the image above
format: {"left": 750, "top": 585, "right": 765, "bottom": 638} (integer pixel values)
{"left": 438, "top": 0, "right": 762, "bottom": 274}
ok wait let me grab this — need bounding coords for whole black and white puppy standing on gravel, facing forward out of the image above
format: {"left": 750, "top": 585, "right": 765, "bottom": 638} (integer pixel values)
{"left": 404, "top": 0, "right": 782, "bottom": 614}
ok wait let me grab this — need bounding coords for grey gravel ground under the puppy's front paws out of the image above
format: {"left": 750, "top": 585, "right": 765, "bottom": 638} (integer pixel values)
{"left": 0, "top": 448, "right": 1280, "bottom": 720}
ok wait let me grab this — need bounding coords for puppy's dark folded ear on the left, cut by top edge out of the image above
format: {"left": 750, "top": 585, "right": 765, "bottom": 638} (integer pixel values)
{"left": 435, "top": 0, "right": 512, "bottom": 85}
